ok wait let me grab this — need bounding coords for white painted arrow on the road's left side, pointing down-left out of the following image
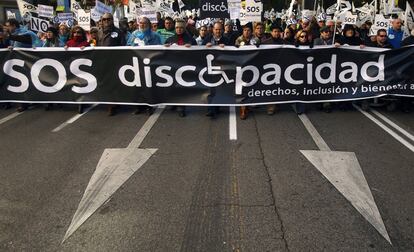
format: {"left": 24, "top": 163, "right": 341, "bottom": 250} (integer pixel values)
{"left": 62, "top": 107, "right": 165, "bottom": 243}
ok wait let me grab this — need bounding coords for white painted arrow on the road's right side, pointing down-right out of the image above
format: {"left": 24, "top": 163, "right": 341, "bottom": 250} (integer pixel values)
{"left": 298, "top": 114, "right": 392, "bottom": 245}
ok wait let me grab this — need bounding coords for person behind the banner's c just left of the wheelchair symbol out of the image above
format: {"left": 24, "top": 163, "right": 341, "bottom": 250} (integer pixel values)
{"left": 164, "top": 19, "right": 197, "bottom": 117}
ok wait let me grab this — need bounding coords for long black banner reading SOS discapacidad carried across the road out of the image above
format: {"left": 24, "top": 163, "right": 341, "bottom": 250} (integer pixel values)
{"left": 0, "top": 46, "right": 414, "bottom": 106}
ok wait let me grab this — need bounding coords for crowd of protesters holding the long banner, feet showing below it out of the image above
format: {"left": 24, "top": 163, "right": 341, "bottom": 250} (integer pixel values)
{"left": 0, "top": 13, "right": 414, "bottom": 119}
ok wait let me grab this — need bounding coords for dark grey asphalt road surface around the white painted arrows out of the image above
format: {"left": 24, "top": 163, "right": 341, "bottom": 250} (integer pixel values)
{"left": 0, "top": 105, "right": 414, "bottom": 252}
